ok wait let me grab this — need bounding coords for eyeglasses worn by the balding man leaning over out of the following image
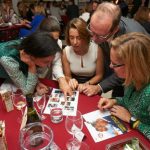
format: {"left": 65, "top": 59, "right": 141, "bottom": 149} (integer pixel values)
{"left": 87, "top": 24, "right": 112, "bottom": 40}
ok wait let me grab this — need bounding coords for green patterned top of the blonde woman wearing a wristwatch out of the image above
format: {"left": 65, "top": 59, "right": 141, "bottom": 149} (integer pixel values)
{"left": 116, "top": 83, "right": 150, "bottom": 139}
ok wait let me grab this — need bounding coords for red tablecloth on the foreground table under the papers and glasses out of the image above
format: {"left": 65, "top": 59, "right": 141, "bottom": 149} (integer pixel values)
{"left": 0, "top": 80, "right": 150, "bottom": 150}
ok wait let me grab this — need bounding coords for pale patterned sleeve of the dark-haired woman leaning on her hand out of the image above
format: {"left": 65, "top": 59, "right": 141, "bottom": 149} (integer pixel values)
{"left": 0, "top": 56, "right": 38, "bottom": 94}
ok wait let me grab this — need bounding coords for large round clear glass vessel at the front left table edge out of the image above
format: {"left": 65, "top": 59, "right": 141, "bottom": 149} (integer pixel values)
{"left": 20, "top": 122, "right": 53, "bottom": 150}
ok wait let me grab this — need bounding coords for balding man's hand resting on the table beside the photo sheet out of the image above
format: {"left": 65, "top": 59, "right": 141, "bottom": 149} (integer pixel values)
{"left": 83, "top": 85, "right": 101, "bottom": 96}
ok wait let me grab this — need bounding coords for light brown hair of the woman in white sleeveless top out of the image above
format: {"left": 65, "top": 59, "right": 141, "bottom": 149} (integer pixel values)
{"left": 65, "top": 18, "right": 91, "bottom": 45}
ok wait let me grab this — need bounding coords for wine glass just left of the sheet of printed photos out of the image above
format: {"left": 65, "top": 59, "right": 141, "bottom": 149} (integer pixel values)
{"left": 34, "top": 94, "right": 46, "bottom": 120}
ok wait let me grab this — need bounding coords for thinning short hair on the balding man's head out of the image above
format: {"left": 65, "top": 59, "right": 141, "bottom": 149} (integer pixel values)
{"left": 93, "top": 2, "right": 121, "bottom": 31}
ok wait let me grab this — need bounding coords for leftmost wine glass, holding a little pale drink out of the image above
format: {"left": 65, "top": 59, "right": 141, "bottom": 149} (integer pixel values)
{"left": 11, "top": 93, "right": 26, "bottom": 121}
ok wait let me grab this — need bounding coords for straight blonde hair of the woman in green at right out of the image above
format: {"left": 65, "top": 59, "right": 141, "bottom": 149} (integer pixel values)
{"left": 111, "top": 32, "right": 150, "bottom": 90}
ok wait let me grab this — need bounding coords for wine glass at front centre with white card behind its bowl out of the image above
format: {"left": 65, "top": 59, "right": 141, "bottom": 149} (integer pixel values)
{"left": 65, "top": 111, "right": 83, "bottom": 149}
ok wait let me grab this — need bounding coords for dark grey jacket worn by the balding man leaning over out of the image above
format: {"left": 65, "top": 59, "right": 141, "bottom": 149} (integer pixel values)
{"left": 99, "top": 17, "right": 149, "bottom": 96}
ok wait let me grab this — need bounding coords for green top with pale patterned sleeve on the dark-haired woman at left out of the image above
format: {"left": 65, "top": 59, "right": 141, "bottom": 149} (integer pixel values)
{"left": 0, "top": 40, "right": 38, "bottom": 94}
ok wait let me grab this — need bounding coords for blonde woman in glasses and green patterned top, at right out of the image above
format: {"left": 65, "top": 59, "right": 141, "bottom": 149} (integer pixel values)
{"left": 98, "top": 33, "right": 150, "bottom": 139}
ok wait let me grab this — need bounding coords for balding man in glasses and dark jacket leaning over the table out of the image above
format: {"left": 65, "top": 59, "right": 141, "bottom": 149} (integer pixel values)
{"left": 84, "top": 2, "right": 148, "bottom": 96}
